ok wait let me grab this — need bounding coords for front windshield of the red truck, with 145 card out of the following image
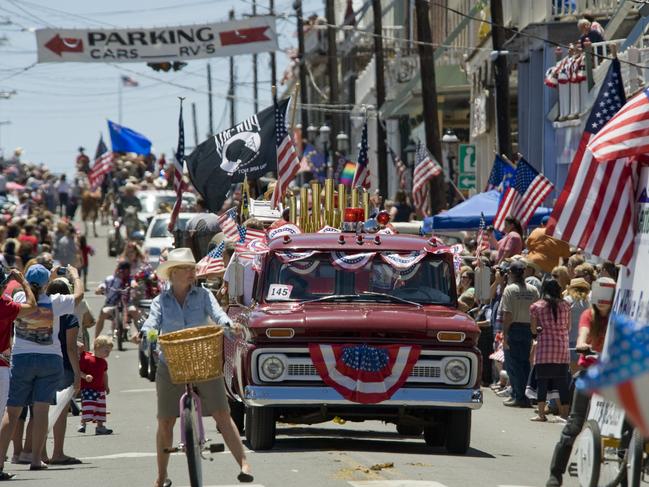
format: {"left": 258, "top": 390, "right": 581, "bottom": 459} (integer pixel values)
{"left": 263, "top": 252, "right": 455, "bottom": 304}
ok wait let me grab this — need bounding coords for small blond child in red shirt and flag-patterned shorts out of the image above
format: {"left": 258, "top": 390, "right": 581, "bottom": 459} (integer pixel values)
{"left": 77, "top": 335, "right": 113, "bottom": 435}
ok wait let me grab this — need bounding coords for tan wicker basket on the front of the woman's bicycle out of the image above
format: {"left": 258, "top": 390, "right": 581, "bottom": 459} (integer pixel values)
{"left": 158, "top": 325, "right": 223, "bottom": 384}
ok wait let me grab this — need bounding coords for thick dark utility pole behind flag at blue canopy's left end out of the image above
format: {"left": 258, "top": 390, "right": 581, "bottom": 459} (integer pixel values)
{"left": 415, "top": 0, "right": 446, "bottom": 215}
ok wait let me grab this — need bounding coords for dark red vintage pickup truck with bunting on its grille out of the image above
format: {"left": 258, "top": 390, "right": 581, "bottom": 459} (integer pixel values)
{"left": 224, "top": 233, "right": 482, "bottom": 454}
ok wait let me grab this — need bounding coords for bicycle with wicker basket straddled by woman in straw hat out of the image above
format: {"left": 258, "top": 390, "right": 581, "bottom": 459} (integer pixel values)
{"left": 158, "top": 326, "right": 225, "bottom": 487}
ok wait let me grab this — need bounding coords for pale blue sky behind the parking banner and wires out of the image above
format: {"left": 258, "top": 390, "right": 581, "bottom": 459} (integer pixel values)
{"left": 0, "top": 0, "right": 324, "bottom": 175}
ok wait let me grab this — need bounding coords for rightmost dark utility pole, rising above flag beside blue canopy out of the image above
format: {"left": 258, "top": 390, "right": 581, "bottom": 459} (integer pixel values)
{"left": 490, "top": 0, "right": 513, "bottom": 158}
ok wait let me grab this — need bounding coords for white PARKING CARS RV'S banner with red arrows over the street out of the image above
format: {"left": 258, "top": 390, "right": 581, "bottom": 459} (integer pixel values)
{"left": 36, "top": 16, "right": 277, "bottom": 63}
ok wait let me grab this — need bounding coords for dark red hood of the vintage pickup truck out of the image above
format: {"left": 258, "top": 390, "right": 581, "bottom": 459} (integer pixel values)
{"left": 249, "top": 303, "right": 480, "bottom": 345}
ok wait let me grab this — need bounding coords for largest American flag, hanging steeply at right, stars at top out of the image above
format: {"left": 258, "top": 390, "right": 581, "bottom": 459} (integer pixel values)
{"left": 546, "top": 59, "right": 646, "bottom": 265}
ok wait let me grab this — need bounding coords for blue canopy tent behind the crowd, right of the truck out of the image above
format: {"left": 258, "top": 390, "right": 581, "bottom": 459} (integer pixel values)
{"left": 422, "top": 190, "right": 552, "bottom": 233}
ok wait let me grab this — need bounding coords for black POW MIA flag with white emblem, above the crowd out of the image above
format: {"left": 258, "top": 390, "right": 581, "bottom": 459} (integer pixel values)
{"left": 185, "top": 99, "right": 288, "bottom": 212}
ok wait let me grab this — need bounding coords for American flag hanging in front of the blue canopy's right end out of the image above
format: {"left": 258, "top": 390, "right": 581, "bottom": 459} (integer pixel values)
{"left": 494, "top": 158, "right": 554, "bottom": 232}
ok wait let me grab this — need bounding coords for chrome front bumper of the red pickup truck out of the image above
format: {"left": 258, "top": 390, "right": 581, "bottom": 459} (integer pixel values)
{"left": 244, "top": 386, "right": 482, "bottom": 409}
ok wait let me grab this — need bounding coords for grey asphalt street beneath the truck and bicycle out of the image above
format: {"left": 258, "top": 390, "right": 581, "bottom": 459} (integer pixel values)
{"left": 6, "top": 227, "right": 577, "bottom": 487}
